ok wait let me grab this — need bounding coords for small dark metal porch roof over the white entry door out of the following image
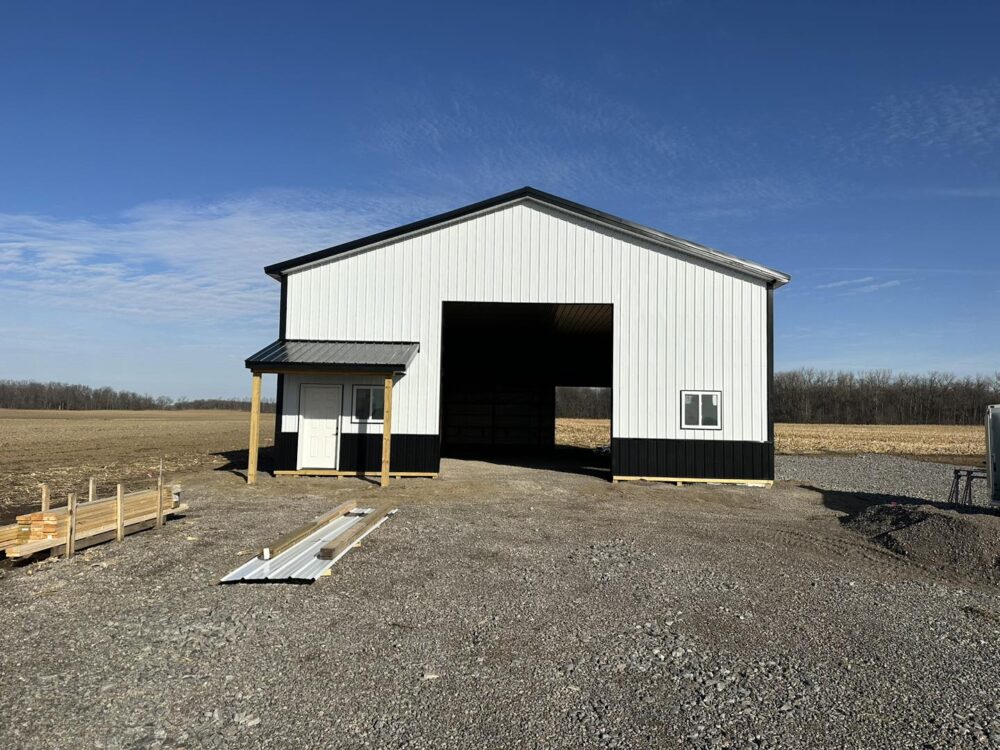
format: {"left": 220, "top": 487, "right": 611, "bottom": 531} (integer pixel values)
{"left": 246, "top": 339, "right": 420, "bottom": 373}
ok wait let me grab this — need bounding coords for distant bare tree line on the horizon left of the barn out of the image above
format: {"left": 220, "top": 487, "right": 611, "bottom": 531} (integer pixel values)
{"left": 0, "top": 380, "right": 274, "bottom": 412}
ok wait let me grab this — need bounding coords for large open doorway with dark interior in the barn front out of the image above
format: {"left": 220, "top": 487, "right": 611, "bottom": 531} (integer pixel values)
{"left": 441, "top": 302, "right": 614, "bottom": 473}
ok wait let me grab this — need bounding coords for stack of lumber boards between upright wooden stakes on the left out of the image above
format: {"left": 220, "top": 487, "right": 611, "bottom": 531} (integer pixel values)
{"left": 0, "top": 486, "right": 187, "bottom": 558}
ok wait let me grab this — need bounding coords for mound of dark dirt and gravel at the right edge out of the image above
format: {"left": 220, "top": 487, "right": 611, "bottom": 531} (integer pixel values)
{"left": 844, "top": 504, "right": 1000, "bottom": 586}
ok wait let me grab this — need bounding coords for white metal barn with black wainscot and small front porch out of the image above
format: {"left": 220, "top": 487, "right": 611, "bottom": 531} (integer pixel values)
{"left": 246, "top": 188, "right": 789, "bottom": 483}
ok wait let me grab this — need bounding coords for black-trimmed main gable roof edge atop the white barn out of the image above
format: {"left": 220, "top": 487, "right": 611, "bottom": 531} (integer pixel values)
{"left": 264, "top": 187, "right": 791, "bottom": 287}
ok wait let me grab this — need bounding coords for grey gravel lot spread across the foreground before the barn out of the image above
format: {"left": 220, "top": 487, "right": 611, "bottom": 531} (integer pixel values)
{"left": 0, "top": 457, "right": 1000, "bottom": 748}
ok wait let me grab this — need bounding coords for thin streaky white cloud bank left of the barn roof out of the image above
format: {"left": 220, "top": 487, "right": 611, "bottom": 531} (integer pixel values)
{"left": 0, "top": 192, "right": 436, "bottom": 324}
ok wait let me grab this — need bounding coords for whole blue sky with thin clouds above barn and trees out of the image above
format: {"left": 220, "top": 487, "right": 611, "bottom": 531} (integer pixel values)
{"left": 0, "top": 1, "right": 1000, "bottom": 397}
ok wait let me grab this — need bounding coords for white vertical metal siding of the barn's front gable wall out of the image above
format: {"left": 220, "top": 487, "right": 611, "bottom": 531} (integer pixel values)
{"left": 282, "top": 199, "right": 767, "bottom": 441}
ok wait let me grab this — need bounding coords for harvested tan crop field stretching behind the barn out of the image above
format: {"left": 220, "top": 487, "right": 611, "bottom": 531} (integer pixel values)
{"left": 0, "top": 409, "right": 984, "bottom": 522}
